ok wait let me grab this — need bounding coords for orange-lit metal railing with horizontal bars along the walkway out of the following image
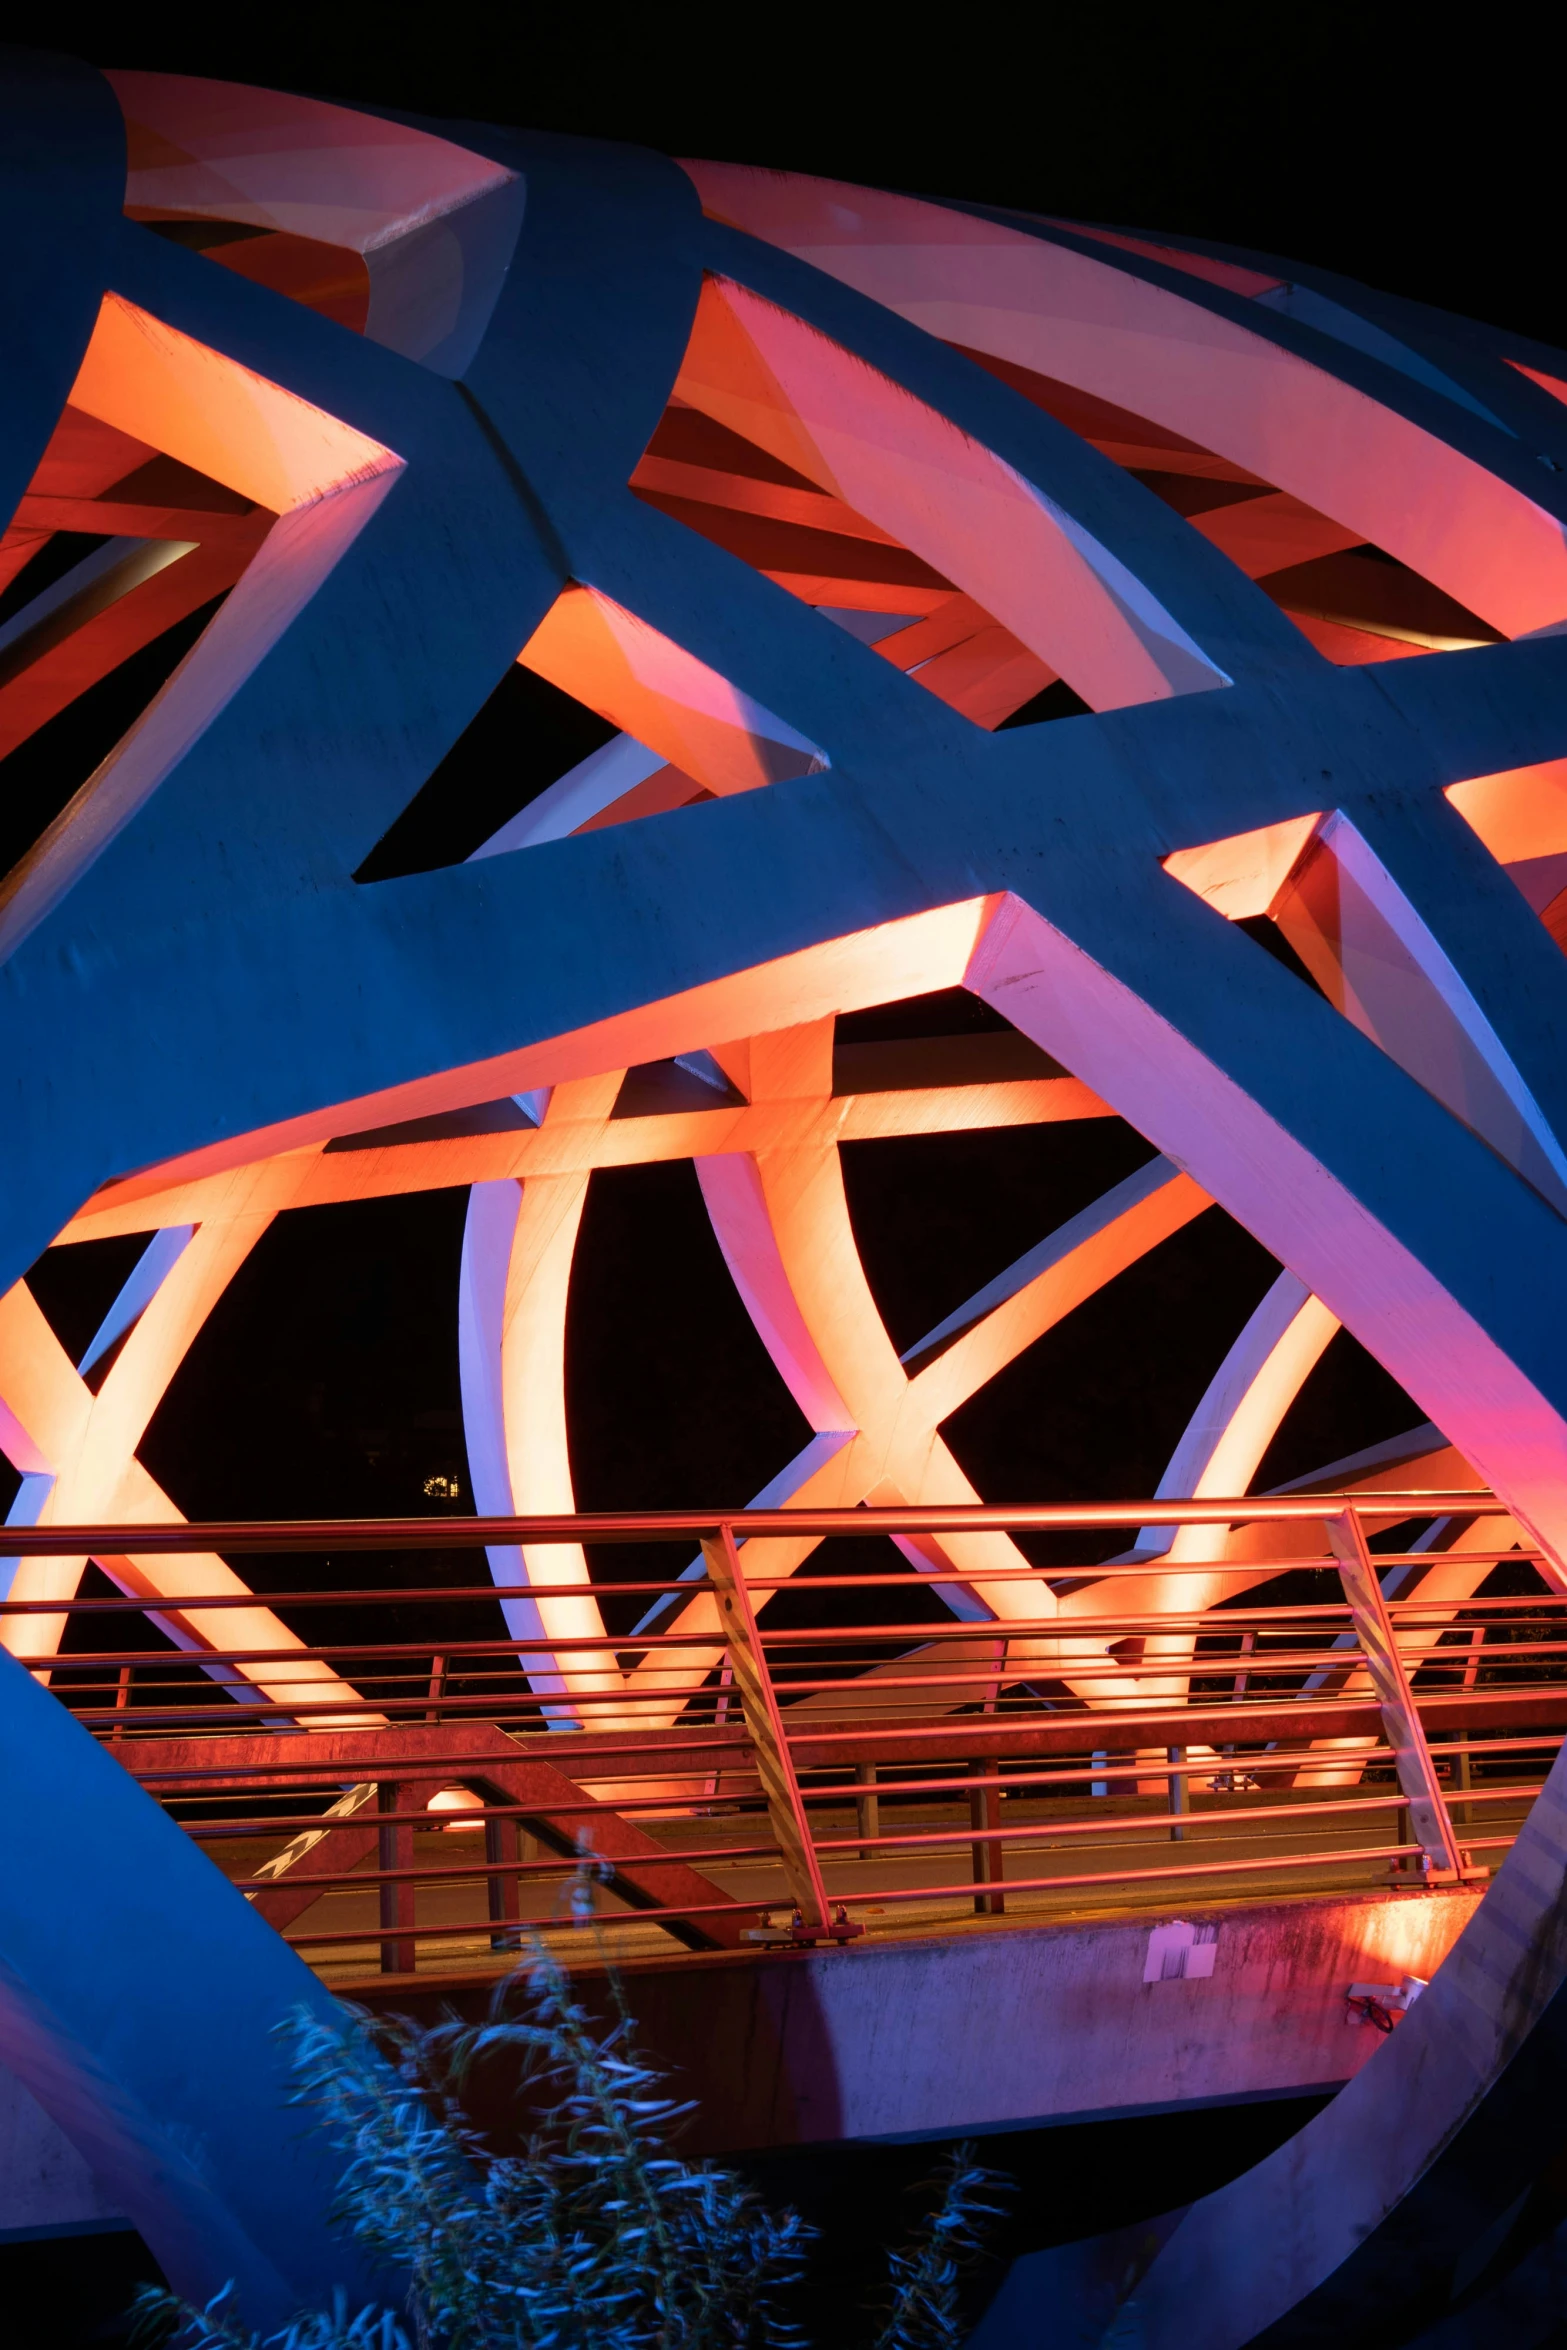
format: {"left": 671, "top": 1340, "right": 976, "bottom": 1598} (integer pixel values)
{"left": 0, "top": 1492, "right": 1567, "bottom": 1979}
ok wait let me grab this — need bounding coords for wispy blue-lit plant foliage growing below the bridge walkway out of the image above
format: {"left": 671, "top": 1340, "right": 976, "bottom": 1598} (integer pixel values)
{"left": 134, "top": 1943, "right": 996, "bottom": 2350}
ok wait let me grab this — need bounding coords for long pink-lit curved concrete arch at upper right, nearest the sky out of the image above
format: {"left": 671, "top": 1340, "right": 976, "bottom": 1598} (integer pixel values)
{"left": 686, "top": 165, "right": 1567, "bottom": 635}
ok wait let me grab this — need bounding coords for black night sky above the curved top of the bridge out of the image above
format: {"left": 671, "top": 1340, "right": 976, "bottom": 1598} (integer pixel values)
{"left": 21, "top": 0, "right": 1567, "bottom": 343}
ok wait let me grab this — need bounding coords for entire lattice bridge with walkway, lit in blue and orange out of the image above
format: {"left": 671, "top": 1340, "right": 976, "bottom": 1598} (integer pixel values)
{"left": 0, "top": 56, "right": 1567, "bottom": 2350}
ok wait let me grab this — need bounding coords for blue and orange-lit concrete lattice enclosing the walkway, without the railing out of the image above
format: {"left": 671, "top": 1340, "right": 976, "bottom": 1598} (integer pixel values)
{"left": 0, "top": 50, "right": 1567, "bottom": 2343}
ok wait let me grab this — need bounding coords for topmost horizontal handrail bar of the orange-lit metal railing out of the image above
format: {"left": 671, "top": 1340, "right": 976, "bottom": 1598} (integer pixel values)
{"left": 0, "top": 1488, "right": 1506, "bottom": 1582}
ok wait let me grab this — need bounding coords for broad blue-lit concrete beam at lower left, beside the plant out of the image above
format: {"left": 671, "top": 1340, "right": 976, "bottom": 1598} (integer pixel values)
{"left": 0, "top": 1657, "right": 385, "bottom": 2327}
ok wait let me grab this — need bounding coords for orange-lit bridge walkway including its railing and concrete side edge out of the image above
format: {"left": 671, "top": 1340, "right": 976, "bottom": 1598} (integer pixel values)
{"left": 2, "top": 1475, "right": 1567, "bottom": 2340}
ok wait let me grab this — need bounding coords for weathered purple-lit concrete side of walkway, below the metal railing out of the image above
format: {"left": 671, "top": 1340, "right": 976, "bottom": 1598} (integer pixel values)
{"left": 355, "top": 1892, "right": 1478, "bottom": 2153}
